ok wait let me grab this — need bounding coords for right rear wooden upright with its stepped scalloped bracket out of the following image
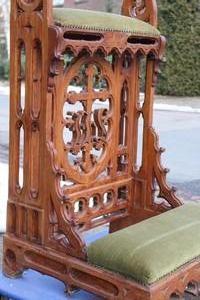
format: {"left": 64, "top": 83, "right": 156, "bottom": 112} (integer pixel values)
{"left": 136, "top": 46, "right": 182, "bottom": 211}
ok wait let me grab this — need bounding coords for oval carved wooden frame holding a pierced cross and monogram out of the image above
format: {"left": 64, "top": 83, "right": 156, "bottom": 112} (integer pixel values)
{"left": 54, "top": 58, "right": 113, "bottom": 183}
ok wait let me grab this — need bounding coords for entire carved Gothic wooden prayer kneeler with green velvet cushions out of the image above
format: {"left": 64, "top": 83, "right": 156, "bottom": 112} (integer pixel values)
{"left": 3, "top": 0, "right": 200, "bottom": 300}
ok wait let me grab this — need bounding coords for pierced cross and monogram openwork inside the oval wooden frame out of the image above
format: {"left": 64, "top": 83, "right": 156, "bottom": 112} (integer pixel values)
{"left": 64, "top": 63, "right": 111, "bottom": 173}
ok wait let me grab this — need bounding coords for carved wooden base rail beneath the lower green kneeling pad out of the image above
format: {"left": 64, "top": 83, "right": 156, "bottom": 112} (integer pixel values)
{"left": 4, "top": 235, "right": 200, "bottom": 300}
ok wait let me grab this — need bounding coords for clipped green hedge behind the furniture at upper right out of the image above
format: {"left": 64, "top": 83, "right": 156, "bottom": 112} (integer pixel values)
{"left": 157, "top": 0, "right": 200, "bottom": 96}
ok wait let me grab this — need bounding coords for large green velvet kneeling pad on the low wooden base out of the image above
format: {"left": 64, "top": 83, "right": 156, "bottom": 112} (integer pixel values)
{"left": 87, "top": 203, "right": 200, "bottom": 285}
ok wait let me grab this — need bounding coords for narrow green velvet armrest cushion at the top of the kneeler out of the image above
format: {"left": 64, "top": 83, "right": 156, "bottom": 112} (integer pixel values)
{"left": 53, "top": 8, "right": 160, "bottom": 37}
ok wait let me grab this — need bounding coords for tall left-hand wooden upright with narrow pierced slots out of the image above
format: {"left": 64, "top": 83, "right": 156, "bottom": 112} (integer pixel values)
{"left": 4, "top": 0, "right": 52, "bottom": 276}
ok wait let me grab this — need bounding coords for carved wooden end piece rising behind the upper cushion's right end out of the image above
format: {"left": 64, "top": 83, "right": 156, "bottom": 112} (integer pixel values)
{"left": 121, "top": 0, "right": 157, "bottom": 27}
